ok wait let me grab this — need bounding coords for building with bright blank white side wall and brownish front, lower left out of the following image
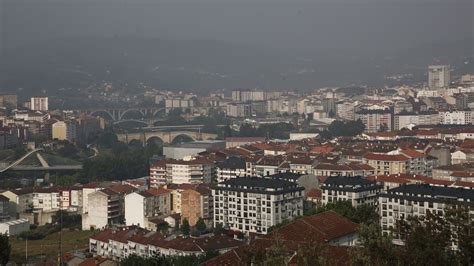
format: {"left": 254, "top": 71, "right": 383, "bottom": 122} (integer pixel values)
{"left": 125, "top": 188, "right": 171, "bottom": 230}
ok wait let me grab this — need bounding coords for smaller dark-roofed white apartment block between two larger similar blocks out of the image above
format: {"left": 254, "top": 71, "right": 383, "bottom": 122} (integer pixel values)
{"left": 321, "top": 176, "right": 383, "bottom": 206}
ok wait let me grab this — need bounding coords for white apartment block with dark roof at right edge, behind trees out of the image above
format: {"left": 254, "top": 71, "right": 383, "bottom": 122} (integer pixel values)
{"left": 378, "top": 184, "right": 474, "bottom": 237}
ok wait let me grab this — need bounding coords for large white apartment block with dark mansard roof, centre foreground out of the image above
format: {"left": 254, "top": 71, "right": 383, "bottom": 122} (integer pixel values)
{"left": 212, "top": 177, "right": 304, "bottom": 234}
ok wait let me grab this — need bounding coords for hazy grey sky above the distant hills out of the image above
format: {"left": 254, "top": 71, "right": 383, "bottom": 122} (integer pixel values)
{"left": 0, "top": 0, "right": 474, "bottom": 56}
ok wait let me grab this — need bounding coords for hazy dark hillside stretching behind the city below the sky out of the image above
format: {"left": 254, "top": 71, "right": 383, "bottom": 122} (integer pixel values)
{"left": 0, "top": 37, "right": 474, "bottom": 94}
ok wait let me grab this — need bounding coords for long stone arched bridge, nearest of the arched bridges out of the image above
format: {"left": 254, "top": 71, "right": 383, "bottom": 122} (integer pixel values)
{"left": 117, "top": 131, "right": 217, "bottom": 144}
